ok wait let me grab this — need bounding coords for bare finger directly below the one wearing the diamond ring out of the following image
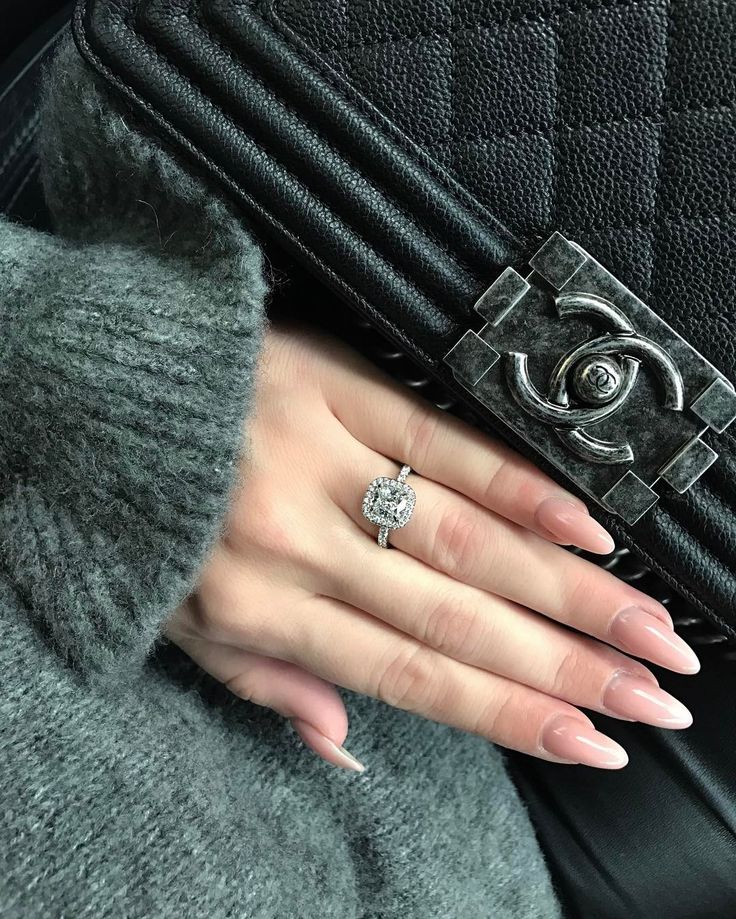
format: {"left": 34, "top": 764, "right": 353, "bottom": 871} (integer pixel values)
{"left": 322, "top": 452, "right": 692, "bottom": 727}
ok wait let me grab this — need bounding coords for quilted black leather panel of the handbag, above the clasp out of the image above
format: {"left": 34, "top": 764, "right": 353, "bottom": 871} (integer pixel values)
{"left": 263, "top": 0, "right": 736, "bottom": 613}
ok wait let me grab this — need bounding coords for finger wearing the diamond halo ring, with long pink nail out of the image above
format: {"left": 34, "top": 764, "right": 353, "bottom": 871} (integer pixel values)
{"left": 335, "top": 442, "right": 700, "bottom": 674}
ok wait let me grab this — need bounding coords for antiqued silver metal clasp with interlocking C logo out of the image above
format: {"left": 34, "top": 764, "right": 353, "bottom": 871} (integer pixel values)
{"left": 444, "top": 233, "right": 736, "bottom": 524}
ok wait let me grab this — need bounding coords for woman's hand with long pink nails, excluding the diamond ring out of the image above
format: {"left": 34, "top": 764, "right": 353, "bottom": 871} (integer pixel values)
{"left": 167, "top": 325, "right": 699, "bottom": 770}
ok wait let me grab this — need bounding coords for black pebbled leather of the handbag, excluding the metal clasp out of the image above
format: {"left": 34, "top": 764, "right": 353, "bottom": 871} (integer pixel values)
{"left": 70, "top": 0, "right": 736, "bottom": 637}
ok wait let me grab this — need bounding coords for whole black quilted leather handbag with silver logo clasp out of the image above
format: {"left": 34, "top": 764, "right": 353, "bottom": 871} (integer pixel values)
{"left": 74, "top": 0, "right": 736, "bottom": 637}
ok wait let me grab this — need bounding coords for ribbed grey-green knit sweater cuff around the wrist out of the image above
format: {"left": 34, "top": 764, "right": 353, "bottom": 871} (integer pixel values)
{"left": 0, "top": 40, "right": 267, "bottom": 678}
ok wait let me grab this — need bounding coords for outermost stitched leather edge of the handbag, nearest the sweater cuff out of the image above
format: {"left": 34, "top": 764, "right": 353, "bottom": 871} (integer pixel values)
{"left": 73, "top": 0, "right": 436, "bottom": 367}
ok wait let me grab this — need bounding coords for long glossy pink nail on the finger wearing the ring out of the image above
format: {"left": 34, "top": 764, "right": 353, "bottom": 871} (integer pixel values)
{"left": 608, "top": 606, "right": 700, "bottom": 673}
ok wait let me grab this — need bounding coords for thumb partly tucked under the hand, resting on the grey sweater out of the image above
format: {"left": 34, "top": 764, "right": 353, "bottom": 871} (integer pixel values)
{"left": 176, "top": 637, "right": 365, "bottom": 772}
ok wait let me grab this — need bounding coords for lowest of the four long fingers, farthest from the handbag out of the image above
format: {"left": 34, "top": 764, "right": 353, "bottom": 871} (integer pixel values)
{"left": 279, "top": 596, "right": 628, "bottom": 769}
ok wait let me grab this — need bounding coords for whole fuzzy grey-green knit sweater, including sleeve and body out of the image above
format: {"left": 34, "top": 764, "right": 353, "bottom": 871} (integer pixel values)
{"left": 0, "top": 34, "right": 559, "bottom": 919}
